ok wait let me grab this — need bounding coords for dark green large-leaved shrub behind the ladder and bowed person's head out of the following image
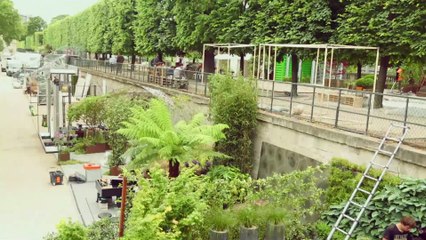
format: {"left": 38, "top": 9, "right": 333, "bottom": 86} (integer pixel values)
{"left": 324, "top": 179, "right": 426, "bottom": 239}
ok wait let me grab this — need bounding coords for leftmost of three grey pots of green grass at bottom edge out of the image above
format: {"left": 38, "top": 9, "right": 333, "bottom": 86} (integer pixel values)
{"left": 206, "top": 209, "right": 235, "bottom": 240}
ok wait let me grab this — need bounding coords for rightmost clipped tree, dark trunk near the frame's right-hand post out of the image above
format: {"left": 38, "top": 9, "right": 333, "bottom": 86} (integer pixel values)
{"left": 337, "top": 0, "right": 426, "bottom": 108}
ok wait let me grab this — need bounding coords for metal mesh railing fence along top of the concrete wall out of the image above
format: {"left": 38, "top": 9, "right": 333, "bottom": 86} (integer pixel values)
{"left": 71, "top": 59, "right": 426, "bottom": 147}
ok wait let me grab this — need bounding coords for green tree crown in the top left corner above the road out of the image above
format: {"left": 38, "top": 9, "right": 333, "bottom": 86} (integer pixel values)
{"left": 0, "top": 0, "right": 23, "bottom": 44}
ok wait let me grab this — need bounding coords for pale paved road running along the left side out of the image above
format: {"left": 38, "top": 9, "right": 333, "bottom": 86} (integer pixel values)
{"left": 0, "top": 73, "right": 81, "bottom": 240}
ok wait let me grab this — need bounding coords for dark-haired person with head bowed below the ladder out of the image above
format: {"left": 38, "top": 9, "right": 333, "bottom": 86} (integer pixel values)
{"left": 382, "top": 216, "right": 416, "bottom": 240}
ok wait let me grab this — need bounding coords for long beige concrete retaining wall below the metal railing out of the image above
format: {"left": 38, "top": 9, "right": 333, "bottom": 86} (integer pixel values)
{"left": 80, "top": 70, "right": 426, "bottom": 178}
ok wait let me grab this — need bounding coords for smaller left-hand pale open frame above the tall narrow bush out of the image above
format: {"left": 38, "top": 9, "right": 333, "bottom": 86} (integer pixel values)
{"left": 201, "top": 43, "right": 257, "bottom": 82}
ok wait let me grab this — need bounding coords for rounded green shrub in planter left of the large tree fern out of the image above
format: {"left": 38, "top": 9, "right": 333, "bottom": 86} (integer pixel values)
{"left": 68, "top": 96, "right": 106, "bottom": 128}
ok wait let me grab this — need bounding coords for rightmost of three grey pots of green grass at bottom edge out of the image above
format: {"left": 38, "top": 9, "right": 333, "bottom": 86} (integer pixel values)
{"left": 262, "top": 204, "right": 288, "bottom": 240}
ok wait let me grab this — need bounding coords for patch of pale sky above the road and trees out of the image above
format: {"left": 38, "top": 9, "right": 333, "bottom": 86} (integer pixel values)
{"left": 12, "top": 0, "right": 98, "bottom": 24}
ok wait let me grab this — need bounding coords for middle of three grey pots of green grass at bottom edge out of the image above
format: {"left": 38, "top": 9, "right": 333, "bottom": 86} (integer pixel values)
{"left": 236, "top": 206, "right": 261, "bottom": 240}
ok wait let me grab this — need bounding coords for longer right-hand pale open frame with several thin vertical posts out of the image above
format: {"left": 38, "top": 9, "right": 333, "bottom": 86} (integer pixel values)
{"left": 253, "top": 43, "right": 380, "bottom": 92}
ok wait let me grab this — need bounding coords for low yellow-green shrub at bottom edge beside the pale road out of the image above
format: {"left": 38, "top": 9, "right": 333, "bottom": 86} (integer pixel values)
{"left": 43, "top": 219, "right": 88, "bottom": 240}
